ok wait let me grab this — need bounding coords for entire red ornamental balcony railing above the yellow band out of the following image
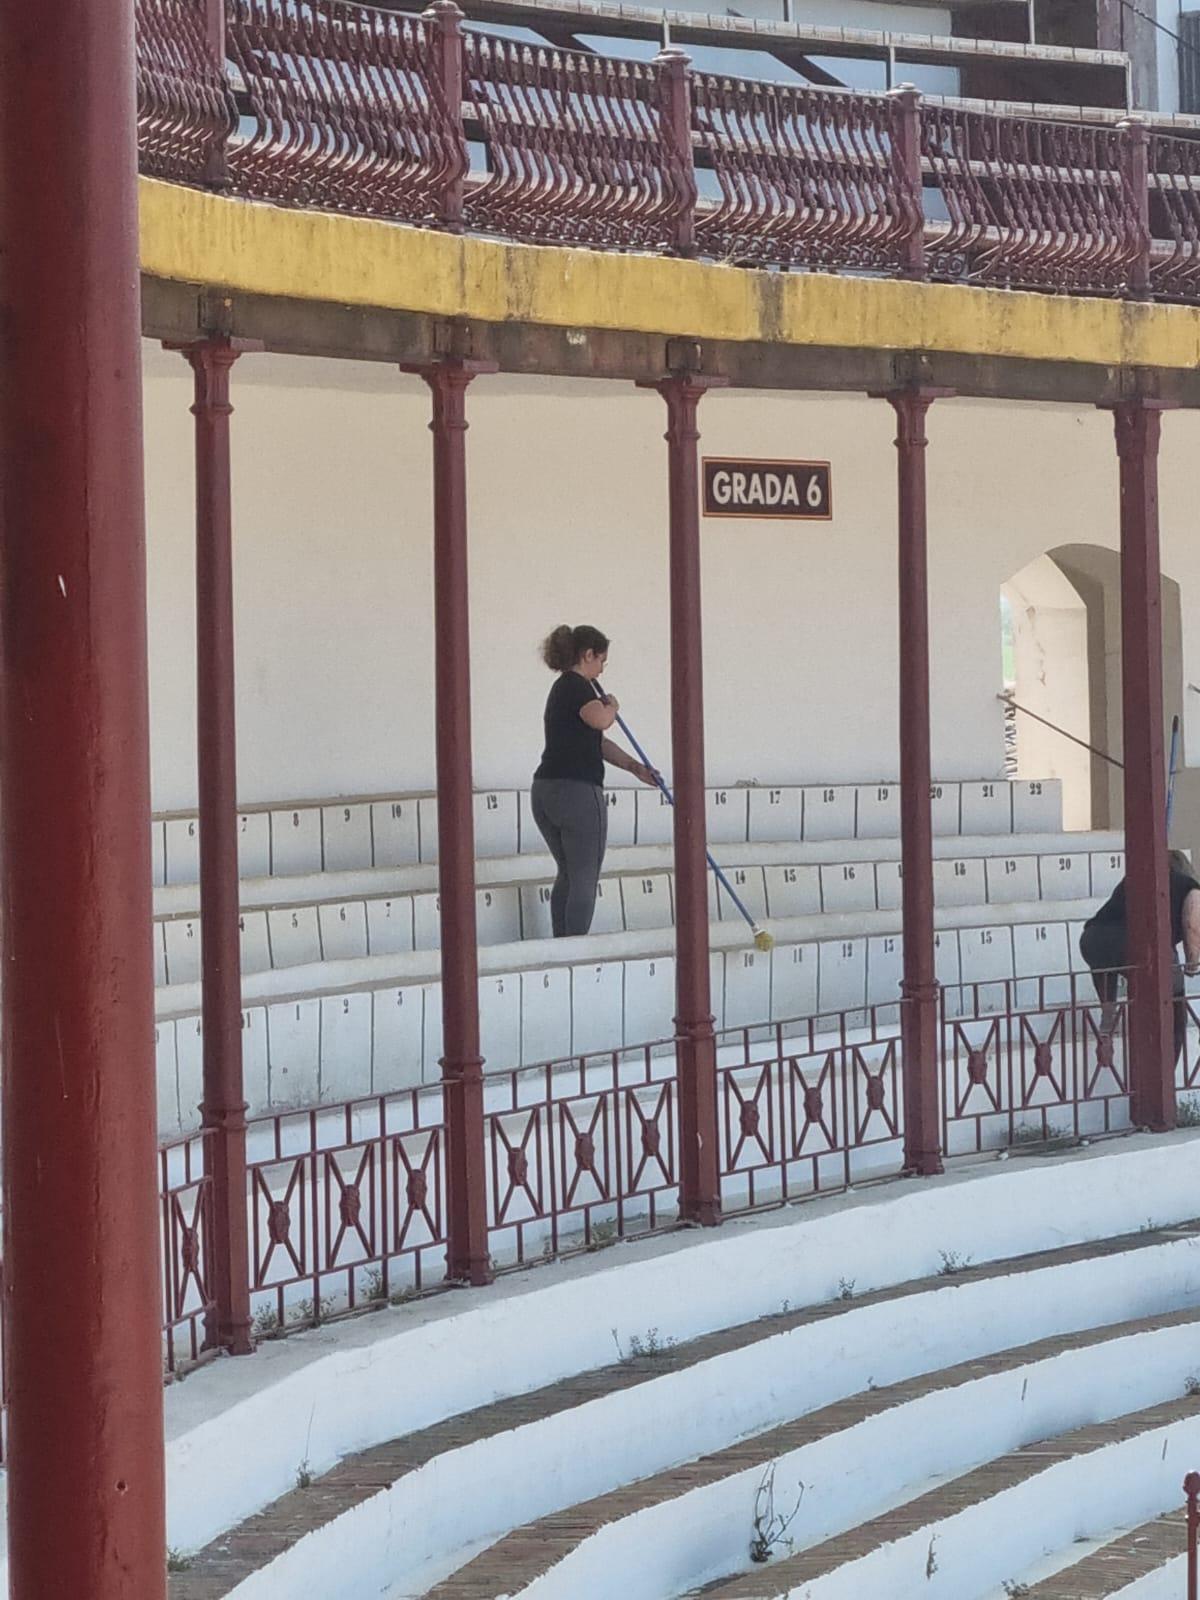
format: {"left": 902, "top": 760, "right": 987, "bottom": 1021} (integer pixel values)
{"left": 129, "top": 0, "right": 1200, "bottom": 299}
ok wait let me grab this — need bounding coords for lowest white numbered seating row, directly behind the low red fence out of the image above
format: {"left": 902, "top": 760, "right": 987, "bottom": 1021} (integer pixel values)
{"left": 157, "top": 906, "right": 1107, "bottom": 1134}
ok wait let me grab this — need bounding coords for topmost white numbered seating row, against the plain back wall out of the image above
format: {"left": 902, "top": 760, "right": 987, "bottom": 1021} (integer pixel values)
{"left": 152, "top": 779, "right": 1062, "bottom": 885}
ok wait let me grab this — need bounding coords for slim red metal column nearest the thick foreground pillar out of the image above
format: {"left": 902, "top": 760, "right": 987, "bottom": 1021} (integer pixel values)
{"left": 184, "top": 336, "right": 253, "bottom": 1355}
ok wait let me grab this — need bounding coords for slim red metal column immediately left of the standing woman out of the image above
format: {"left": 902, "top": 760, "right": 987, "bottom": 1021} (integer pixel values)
{"left": 409, "top": 360, "right": 491, "bottom": 1283}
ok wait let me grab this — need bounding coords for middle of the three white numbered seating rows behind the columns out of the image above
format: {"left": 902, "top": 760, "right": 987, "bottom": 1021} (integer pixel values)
{"left": 155, "top": 850, "right": 1125, "bottom": 987}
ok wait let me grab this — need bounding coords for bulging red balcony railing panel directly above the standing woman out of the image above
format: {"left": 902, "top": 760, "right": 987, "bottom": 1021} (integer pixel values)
{"left": 464, "top": 32, "right": 694, "bottom": 250}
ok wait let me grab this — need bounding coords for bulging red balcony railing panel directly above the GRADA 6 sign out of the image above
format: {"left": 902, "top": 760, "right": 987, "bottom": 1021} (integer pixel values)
{"left": 691, "top": 72, "right": 923, "bottom": 272}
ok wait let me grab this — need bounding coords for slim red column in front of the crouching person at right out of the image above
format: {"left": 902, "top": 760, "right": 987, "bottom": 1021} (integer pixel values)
{"left": 1114, "top": 398, "right": 1174, "bottom": 1130}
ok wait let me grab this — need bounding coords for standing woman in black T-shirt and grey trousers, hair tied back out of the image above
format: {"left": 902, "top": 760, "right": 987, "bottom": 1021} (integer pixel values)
{"left": 530, "top": 626, "right": 658, "bottom": 939}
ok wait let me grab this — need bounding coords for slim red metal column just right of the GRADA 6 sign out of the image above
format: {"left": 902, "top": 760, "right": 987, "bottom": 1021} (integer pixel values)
{"left": 888, "top": 389, "right": 942, "bottom": 1178}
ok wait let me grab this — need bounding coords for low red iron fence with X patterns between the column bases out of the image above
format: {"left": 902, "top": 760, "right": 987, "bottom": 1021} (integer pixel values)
{"left": 0, "top": 974, "right": 1177, "bottom": 1465}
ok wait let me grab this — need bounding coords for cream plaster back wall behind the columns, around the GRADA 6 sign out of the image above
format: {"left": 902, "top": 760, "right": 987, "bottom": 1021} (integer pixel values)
{"left": 146, "top": 358, "right": 1200, "bottom": 810}
